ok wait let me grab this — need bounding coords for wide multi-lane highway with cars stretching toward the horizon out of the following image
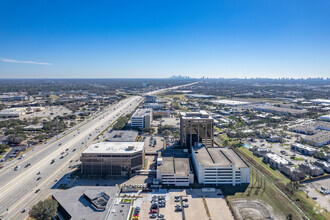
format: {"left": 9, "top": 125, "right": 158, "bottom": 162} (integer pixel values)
{"left": 0, "top": 81, "right": 196, "bottom": 219}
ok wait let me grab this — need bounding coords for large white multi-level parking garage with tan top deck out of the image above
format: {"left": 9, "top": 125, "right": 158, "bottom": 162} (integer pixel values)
{"left": 191, "top": 145, "right": 250, "bottom": 186}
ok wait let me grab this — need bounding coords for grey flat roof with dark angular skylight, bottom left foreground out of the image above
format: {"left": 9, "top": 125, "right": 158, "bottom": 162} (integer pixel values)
{"left": 53, "top": 186, "right": 119, "bottom": 220}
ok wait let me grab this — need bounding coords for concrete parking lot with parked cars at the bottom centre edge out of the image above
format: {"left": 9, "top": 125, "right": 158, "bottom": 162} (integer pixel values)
{"left": 136, "top": 189, "right": 233, "bottom": 220}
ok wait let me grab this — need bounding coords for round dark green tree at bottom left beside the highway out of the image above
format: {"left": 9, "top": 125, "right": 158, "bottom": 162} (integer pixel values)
{"left": 29, "top": 199, "right": 58, "bottom": 220}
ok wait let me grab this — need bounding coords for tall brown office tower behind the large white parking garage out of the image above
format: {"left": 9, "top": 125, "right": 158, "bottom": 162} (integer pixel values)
{"left": 180, "top": 111, "right": 214, "bottom": 149}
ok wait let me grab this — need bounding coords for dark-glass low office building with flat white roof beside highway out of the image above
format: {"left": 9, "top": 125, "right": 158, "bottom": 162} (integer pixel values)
{"left": 80, "top": 142, "right": 144, "bottom": 176}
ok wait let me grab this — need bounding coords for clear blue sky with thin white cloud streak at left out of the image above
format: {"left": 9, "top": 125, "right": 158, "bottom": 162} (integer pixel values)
{"left": 0, "top": 0, "right": 330, "bottom": 78}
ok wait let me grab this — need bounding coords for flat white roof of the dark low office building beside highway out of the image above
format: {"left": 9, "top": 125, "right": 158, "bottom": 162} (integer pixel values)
{"left": 83, "top": 141, "right": 144, "bottom": 154}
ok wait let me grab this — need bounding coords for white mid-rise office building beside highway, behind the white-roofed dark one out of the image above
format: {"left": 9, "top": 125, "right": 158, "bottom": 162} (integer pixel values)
{"left": 131, "top": 108, "right": 152, "bottom": 128}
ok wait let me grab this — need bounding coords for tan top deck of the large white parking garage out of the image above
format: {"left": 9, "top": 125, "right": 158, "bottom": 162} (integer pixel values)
{"left": 193, "top": 146, "right": 248, "bottom": 168}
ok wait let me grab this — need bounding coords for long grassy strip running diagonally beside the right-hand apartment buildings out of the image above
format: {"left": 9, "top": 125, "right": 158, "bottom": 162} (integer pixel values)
{"left": 235, "top": 147, "right": 330, "bottom": 220}
